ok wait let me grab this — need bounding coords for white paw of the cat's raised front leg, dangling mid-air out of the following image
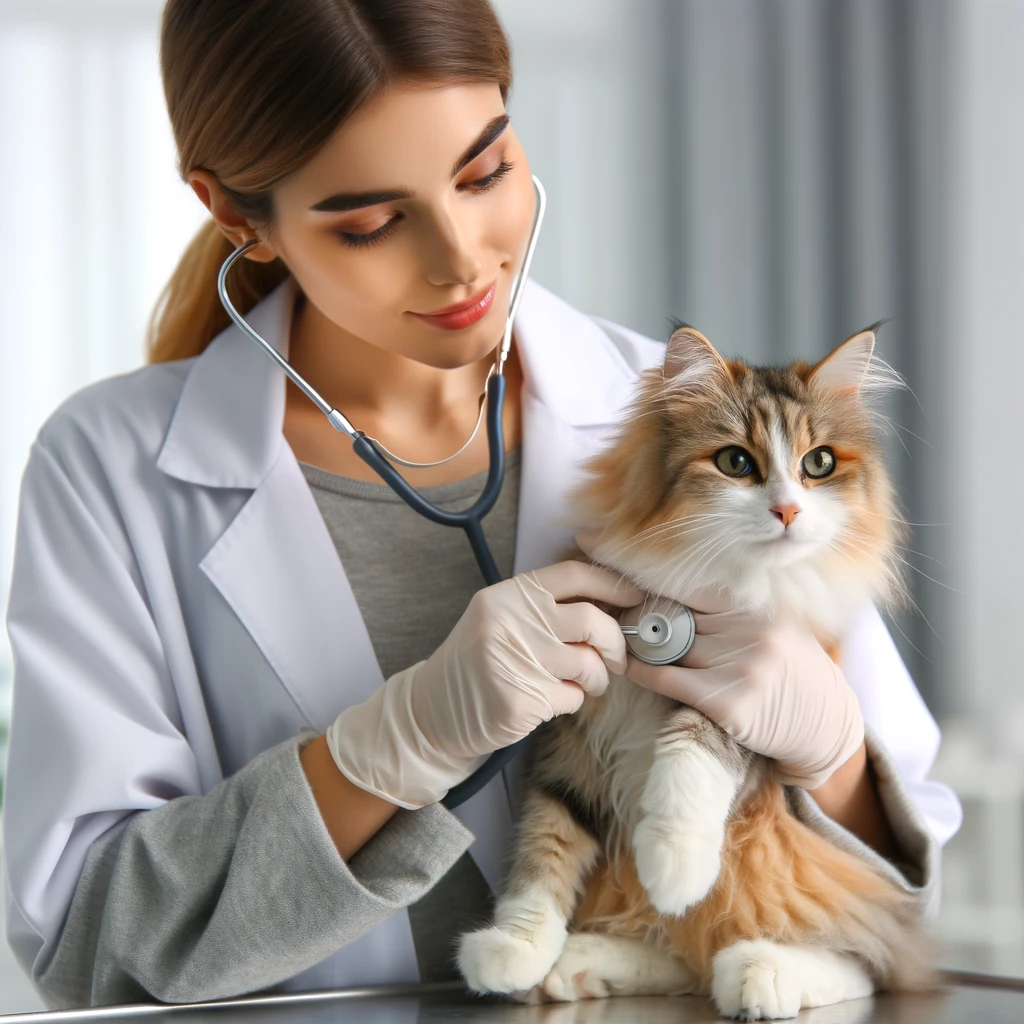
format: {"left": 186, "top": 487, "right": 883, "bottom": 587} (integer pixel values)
{"left": 633, "top": 814, "right": 725, "bottom": 914}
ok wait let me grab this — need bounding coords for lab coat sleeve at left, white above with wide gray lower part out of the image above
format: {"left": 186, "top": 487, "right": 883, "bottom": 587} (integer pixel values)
{"left": 3, "top": 440, "right": 473, "bottom": 1008}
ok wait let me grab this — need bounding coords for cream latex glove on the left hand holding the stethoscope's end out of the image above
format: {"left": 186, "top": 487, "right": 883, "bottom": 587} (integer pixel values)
{"left": 327, "top": 561, "right": 643, "bottom": 809}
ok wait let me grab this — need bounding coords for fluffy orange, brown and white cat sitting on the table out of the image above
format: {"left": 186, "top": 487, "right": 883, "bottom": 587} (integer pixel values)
{"left": 458, "top": 325, "right": 937, "bottom": 1020}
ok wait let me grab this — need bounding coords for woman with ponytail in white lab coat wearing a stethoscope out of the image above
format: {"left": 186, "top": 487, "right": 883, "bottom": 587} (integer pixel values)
{"left": 4, "top": 0, "right": 959, "bottom": 1007}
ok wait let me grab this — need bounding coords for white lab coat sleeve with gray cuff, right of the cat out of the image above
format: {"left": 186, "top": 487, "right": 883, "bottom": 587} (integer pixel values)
{"left": 788, "top": 605, "right": 963, "bottom": 918}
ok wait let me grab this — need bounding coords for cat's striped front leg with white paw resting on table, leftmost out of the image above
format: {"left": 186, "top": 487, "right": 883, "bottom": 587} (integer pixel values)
{"left": 459, "top": 790, "right": 598, "bottom": 994}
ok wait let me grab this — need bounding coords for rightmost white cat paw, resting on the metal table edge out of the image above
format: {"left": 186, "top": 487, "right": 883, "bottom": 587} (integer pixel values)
{"left": 711, "top": 940, "right": 801, "bottom": 1021}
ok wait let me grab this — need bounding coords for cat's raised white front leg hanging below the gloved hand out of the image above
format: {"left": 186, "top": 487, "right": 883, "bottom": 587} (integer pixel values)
{"left": 633, "top": 708, "right": 751, "bottom": 914}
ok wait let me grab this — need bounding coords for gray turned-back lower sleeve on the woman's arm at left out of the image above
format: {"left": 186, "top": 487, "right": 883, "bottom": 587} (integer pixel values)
{"left": 33, "top": 731, "right": 473, "bottom": 1009}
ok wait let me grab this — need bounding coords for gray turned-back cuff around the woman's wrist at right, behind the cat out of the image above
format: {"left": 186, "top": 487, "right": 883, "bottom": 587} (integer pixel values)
{"left": 787, "top": 723, "right": 942, "bottom": 918}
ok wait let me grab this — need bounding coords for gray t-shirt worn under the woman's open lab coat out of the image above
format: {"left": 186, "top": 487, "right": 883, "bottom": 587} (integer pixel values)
{"left": 299, "top": 449, "right": 519, "bottom": 981}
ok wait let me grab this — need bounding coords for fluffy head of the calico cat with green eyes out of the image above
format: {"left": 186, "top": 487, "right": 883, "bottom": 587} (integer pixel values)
{"left": 573, "top": 326, "right": 905, "bottom": 635}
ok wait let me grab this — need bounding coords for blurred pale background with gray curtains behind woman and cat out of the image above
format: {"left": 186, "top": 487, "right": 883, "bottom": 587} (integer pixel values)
{"left": 0, "top": 0, "right": 1024, "bottom": 1012}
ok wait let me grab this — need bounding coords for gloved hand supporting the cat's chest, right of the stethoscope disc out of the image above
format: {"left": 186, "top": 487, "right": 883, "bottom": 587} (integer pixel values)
{"left": 626, "top": 592, "right": 864, "bottom": 790}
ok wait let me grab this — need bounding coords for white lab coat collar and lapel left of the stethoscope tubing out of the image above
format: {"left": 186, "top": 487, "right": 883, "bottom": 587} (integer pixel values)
{"left": 158, "top": 276, "right": 383, "bottom": 732}
